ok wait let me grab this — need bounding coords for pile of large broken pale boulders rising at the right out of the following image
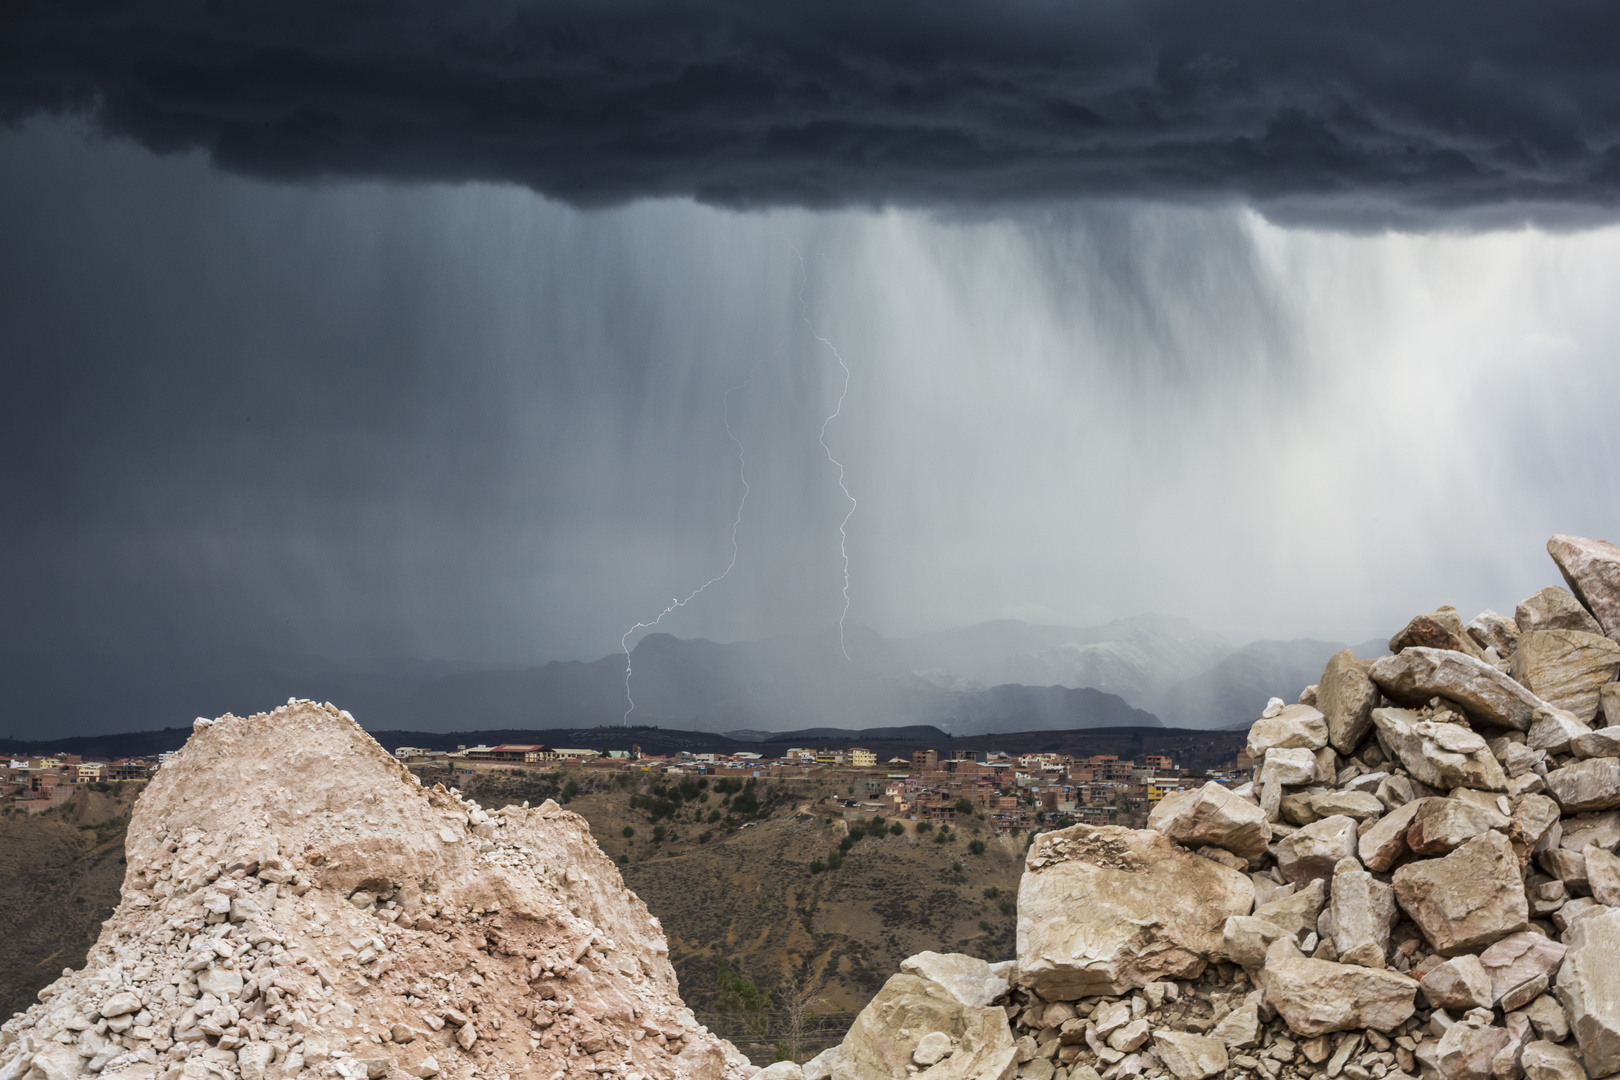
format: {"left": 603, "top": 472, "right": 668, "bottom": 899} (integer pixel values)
{"left": 793, "top": 536, "right": 1620, "bottom": 1080}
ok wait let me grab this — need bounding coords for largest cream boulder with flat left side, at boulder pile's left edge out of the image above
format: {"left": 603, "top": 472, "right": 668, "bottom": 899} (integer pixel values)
{"left": 1017, "top": 824, "right": 1254, "bottom": 1001}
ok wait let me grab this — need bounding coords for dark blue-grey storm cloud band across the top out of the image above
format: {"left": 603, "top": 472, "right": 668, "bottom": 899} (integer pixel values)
{"left": 9, "top": 0, "right": 1620, "bottom": 227}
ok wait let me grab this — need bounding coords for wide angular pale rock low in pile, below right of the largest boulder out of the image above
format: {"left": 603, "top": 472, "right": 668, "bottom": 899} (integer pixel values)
{"left": 1264, "top": 939, "right": 1418, "bottom": 1038}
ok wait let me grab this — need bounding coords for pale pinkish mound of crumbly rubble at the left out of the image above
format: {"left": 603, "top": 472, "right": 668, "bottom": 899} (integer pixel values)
{"left": 0, "top": 701, "right": 757, "bottom": 1080}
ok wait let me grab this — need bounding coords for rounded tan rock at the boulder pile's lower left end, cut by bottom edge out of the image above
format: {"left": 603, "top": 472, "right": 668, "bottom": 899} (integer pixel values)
{"left": 834, "top": 973, "right": 1017, "bottom": 1080}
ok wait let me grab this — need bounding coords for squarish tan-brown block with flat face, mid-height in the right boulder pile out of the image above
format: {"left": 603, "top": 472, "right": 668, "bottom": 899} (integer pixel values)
{"left": 1393, "top": 832, "right": 1529, "bottom": 957}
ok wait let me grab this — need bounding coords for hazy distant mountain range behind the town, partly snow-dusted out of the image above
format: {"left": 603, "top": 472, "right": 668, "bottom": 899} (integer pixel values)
{"left": 0, "top": 615, "right": 1383, "bottom": 738}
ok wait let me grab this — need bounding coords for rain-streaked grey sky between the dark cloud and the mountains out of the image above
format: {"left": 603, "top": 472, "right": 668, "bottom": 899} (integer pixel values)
{"left": 0, "top": 120, "right": 1620, "bottom": 683}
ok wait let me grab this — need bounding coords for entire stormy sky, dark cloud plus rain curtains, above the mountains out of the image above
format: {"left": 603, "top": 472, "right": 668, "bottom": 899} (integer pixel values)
{"left": 0, "top": 3, "right": 1620, "bottom": 676}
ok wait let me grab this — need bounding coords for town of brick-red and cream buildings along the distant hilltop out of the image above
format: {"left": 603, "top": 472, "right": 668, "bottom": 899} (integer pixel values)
{"left": 394, "top": 743, "right": 1249, "bottom": 832}
